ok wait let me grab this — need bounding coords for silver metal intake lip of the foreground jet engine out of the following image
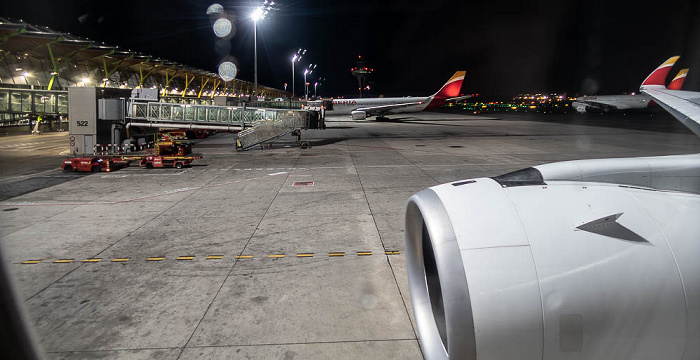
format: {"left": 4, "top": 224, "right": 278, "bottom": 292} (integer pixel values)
{"left": 405, "top": 189, "right": 476, "bottom": 360}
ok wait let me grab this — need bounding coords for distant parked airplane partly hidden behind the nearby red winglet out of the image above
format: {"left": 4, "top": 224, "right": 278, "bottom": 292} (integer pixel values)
{"left": 571, "top": 69, "right": 688, "bottom": 113}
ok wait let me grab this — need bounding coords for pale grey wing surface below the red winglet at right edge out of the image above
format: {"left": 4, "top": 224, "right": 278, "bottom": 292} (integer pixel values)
{"left": 641, "top": 86, "right": 700, "bottom": 136}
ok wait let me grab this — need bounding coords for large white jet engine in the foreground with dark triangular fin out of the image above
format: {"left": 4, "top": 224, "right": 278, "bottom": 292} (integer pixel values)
{"left": 405, "top": 173, "right": 700, "bottom": 360}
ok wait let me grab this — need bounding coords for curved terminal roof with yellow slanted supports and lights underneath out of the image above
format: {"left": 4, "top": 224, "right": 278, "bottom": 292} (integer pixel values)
{"left": 0, "top": 18, "right": 286, "bottom": 97}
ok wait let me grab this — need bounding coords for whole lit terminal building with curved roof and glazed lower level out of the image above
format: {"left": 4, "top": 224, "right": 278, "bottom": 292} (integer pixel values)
{"left": 0, "top": 18, "right": 289, "bottom": 133}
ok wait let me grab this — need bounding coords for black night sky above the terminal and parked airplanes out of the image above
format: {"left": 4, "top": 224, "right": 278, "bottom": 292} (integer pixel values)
{"left": 0, "top": 0, "right": 700, "bottom": 99}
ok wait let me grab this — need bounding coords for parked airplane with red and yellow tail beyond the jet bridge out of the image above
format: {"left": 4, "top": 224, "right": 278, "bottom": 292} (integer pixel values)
{"left": 327, "top": 71, "right": 471, "bottom": 120}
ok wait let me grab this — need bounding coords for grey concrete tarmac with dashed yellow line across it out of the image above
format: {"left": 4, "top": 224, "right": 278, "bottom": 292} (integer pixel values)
{"left": 0, "top": 112, "right": 700, "bottom": 360}
